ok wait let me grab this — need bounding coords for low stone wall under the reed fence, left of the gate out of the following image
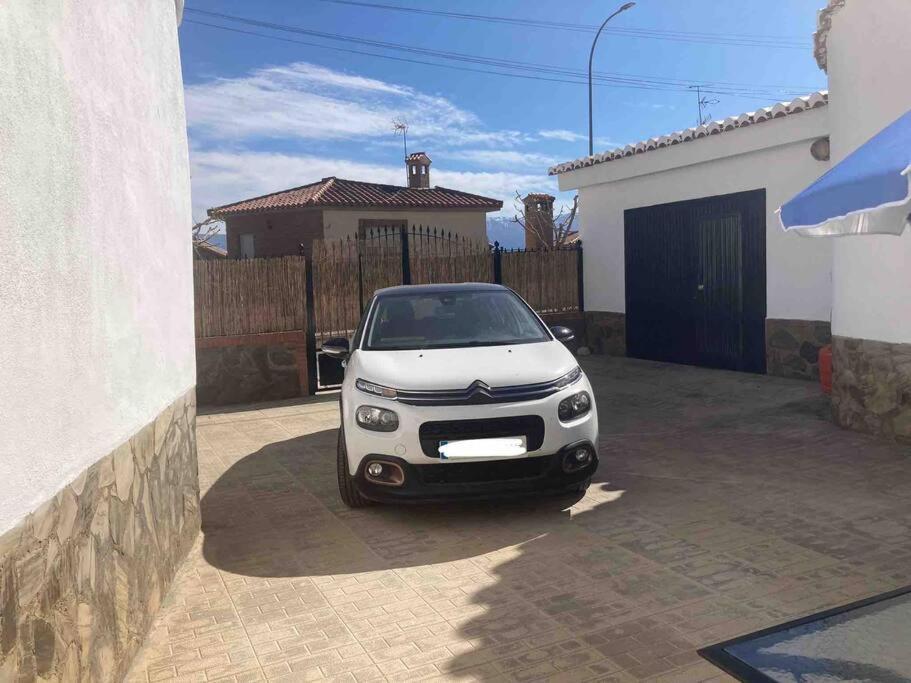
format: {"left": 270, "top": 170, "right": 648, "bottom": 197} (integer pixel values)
{"left": 196, "top": 343, "right": 306, "bottom": 406}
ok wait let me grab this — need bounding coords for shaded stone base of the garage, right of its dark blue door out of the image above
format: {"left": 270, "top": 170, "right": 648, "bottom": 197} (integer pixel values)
{"left": 765, "top": 318, "right": 832, "bottom": 380}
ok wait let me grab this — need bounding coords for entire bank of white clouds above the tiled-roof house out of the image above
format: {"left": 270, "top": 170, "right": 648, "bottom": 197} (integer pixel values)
{"left": 186, "top": 62, "right": 585, "bottom": 218}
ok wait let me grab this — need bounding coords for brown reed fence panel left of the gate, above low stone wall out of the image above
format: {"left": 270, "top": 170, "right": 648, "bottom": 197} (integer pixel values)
{"left": 193, "top": 256, "right": 307, "bottom": 337}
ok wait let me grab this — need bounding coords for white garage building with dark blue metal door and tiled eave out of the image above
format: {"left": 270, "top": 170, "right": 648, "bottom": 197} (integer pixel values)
{"left": 550, "top": 92, "right": 832, "bottom": 377}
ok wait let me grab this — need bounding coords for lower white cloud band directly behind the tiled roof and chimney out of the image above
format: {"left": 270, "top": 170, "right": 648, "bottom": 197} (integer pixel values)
{"left": 190, "top": 149, "right": 557, "bottom": 218}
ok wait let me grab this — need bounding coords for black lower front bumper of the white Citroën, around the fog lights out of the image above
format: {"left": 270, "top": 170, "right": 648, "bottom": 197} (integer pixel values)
{"left": 354, "top": 441, "right": 598, "bottom": 503}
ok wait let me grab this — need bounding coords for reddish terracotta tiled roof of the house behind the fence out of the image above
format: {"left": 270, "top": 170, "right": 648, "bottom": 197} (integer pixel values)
{"left": 208, "top": 176, "right": 503, "bottom": 217}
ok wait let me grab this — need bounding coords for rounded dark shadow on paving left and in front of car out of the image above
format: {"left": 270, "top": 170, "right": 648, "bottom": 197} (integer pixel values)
{"left": 202, "top": 429, "right": 581, "bottom": 577}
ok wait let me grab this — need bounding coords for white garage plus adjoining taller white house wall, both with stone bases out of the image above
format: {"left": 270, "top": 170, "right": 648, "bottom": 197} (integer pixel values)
{"left": 550, "top": 0, "right": 911, "bottom": 440}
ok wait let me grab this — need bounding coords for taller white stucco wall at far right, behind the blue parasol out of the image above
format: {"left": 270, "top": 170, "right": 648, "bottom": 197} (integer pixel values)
{"left": 828, "top": 0, "right": 911, "bottom": 343}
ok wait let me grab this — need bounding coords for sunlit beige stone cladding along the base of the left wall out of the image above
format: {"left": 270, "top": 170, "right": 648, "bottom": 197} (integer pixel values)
{"left": 0, "top": 390, "right": 200, "bottom": 681}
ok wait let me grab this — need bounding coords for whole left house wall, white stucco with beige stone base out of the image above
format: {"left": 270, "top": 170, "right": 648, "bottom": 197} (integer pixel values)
{"left": 0, "top": 0, "right": 200, "bottom": 681}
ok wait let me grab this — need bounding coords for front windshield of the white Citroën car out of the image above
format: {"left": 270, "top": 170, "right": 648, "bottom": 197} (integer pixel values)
{"left": 365, "top": 289, "right": 550, "bottom": 351}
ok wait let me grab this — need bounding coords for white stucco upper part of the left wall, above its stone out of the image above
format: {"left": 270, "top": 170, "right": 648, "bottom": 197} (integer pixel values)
{"left": 0, "top": 0, "right": 195, "bottom": 533}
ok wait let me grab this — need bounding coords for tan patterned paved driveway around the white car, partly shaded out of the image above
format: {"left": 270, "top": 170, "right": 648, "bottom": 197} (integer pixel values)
{"left": 131, "top": 357, "right": 911, "bottom": 681}
